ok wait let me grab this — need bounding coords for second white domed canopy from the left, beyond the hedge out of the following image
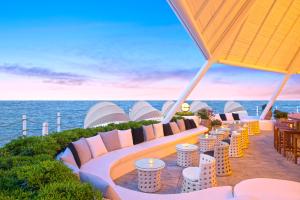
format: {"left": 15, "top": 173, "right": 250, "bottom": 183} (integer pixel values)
{"left": 129, "top": 101, "right": 162, "bottom": 121}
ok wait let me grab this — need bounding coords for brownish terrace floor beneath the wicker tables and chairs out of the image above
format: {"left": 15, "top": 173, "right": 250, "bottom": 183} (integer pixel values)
{"left": 115, "top": 132, "right": 300, "bottom": 194}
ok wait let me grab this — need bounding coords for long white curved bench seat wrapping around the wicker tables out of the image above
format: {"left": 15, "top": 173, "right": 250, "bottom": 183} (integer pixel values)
{"left": 79, "top": 126, "right": 232, "bottom": 200}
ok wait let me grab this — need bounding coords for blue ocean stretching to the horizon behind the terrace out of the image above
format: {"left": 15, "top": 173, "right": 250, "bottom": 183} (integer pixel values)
{"left": 0, "top": 101, "right": 300, "bottom": 146}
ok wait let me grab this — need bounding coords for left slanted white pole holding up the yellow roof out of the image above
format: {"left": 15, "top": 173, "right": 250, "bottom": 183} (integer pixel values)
{"left": 163, "top": 60, "right": 213, "bottom": 123}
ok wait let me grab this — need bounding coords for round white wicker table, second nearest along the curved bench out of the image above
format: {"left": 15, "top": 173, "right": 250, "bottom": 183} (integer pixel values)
{"left": 176, "top": 144, "right": 199, "bottom": 167}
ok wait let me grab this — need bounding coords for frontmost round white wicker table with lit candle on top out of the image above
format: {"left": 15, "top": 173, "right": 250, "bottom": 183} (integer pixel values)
{"left": 135, "top": 158, "right": 165, "bottom": 192}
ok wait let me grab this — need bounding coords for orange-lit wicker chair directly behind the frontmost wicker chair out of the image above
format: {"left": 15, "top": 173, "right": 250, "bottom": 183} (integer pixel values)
{"left": 214, "top": 142, "right": 232, "bottom": 176}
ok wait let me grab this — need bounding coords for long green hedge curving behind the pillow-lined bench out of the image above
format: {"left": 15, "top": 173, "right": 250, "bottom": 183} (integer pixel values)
{"left": 0, "top": 121, "right": 157, "bottom": 200}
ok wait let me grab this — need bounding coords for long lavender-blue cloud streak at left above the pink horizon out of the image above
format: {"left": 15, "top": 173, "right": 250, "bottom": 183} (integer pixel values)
{"left": 0, "top": 64, "right": 90, "bottom": 85}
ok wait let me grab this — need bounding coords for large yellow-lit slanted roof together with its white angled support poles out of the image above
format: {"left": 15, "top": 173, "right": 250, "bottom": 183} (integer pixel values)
{"left": 164, "top": 0, "right": 300, "bottom": 122}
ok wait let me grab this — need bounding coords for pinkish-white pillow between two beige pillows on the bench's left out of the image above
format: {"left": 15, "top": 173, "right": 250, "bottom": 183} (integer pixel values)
{"left": 86, "top": 135, "right": 107, "bottom": 158}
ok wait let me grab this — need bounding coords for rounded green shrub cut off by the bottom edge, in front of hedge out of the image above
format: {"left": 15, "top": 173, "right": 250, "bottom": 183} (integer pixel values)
{"left": 37, "top": 181, "right": 102, "bottom": 200}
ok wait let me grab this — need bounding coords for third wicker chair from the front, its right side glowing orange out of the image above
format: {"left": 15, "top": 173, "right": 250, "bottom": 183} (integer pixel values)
{"left": 229, "top": 132, "right": 244, "bottom": 158}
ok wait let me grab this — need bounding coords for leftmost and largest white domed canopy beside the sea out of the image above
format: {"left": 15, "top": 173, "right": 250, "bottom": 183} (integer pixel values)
{"left": 84, "top": 102, "right": 129, "bottom": 128}
